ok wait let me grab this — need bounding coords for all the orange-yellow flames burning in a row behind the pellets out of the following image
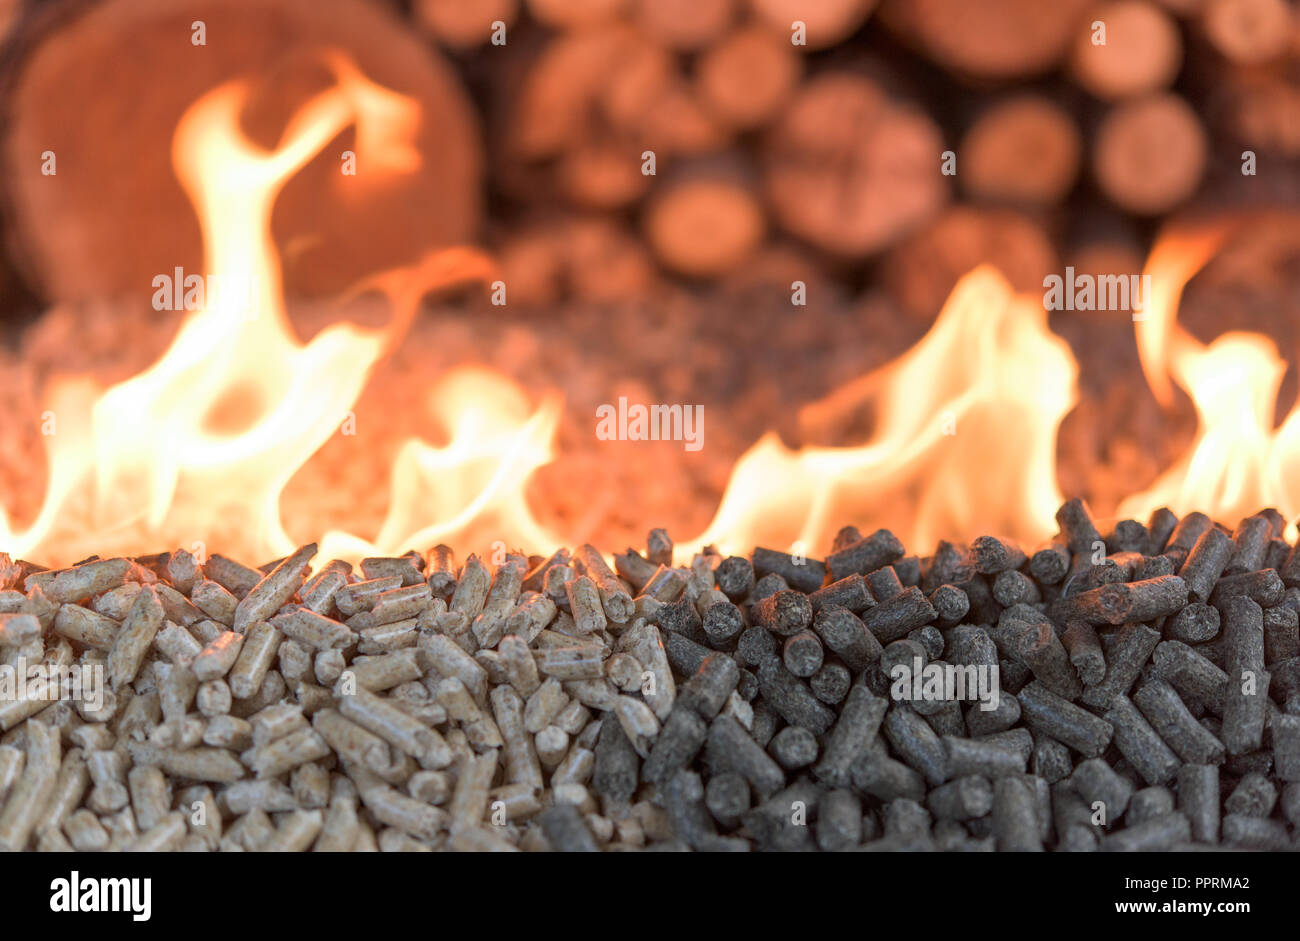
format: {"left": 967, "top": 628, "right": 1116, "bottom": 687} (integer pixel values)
{"left": 0, "top": 56, "right": 1300, "bottom": 564}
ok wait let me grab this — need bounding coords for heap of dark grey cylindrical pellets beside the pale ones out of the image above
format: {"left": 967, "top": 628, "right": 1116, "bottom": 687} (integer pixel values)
{"left": 594, "top": 500, "right": 1300, "bottom": 851}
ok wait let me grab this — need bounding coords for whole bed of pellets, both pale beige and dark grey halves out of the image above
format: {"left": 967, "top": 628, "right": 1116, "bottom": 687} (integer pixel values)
{"left": 0, "top": 500, "right": 1300, "bottom": 851}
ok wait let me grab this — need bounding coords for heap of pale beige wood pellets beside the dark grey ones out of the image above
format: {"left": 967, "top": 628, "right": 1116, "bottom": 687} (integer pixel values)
{"left": 0, "top": 546, "right": 689, "bottom": 851}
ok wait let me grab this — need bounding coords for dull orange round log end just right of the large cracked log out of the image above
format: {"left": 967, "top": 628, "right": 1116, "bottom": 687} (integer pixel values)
{"left": 957, "top": 95, "right": 1083, "bottom": 205}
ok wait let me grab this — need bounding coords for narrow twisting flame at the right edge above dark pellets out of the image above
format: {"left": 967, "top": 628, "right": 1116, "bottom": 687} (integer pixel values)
{"left": 1119, "top": 221, "right": 1300, "bottom": 538}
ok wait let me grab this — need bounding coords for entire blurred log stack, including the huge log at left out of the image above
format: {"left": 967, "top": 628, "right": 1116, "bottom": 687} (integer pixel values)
{"left": 0, "top": 0, "right": 1300, "bottom": 318}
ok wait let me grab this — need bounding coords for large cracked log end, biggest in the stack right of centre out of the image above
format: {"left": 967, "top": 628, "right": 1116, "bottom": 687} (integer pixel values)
{"left": 763, "top": 73, "right": 948, "bottom": 257}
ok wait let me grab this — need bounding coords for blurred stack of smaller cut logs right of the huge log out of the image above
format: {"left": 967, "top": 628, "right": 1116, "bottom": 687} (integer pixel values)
{"left": 415, "top": 0, "right": 1300, "bottom": 318}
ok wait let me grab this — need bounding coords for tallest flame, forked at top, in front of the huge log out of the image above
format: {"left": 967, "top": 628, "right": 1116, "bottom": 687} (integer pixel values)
{"left": 0, "top": 53, "right": 496, "bottom": 561}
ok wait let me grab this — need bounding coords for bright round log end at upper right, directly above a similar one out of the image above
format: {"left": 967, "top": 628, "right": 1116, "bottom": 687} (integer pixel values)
{"left": 1070, "top": 0, "right": 1183, "bottom": 101}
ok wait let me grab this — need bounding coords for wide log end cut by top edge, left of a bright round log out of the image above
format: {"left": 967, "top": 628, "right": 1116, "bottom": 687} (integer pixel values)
{"left": 879, "top": 0, "right": 1091, "bottom": 78}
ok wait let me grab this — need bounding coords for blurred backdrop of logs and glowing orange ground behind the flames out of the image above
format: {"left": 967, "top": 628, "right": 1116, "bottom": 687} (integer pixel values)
{"left": 0, "top": 0, "right": 1300, "bottom": 556}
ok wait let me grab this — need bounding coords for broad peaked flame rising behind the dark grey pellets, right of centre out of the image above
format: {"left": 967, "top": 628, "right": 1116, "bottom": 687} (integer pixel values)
{"left": 698, "top": 268, "right": 1076, "bottom": 551}
